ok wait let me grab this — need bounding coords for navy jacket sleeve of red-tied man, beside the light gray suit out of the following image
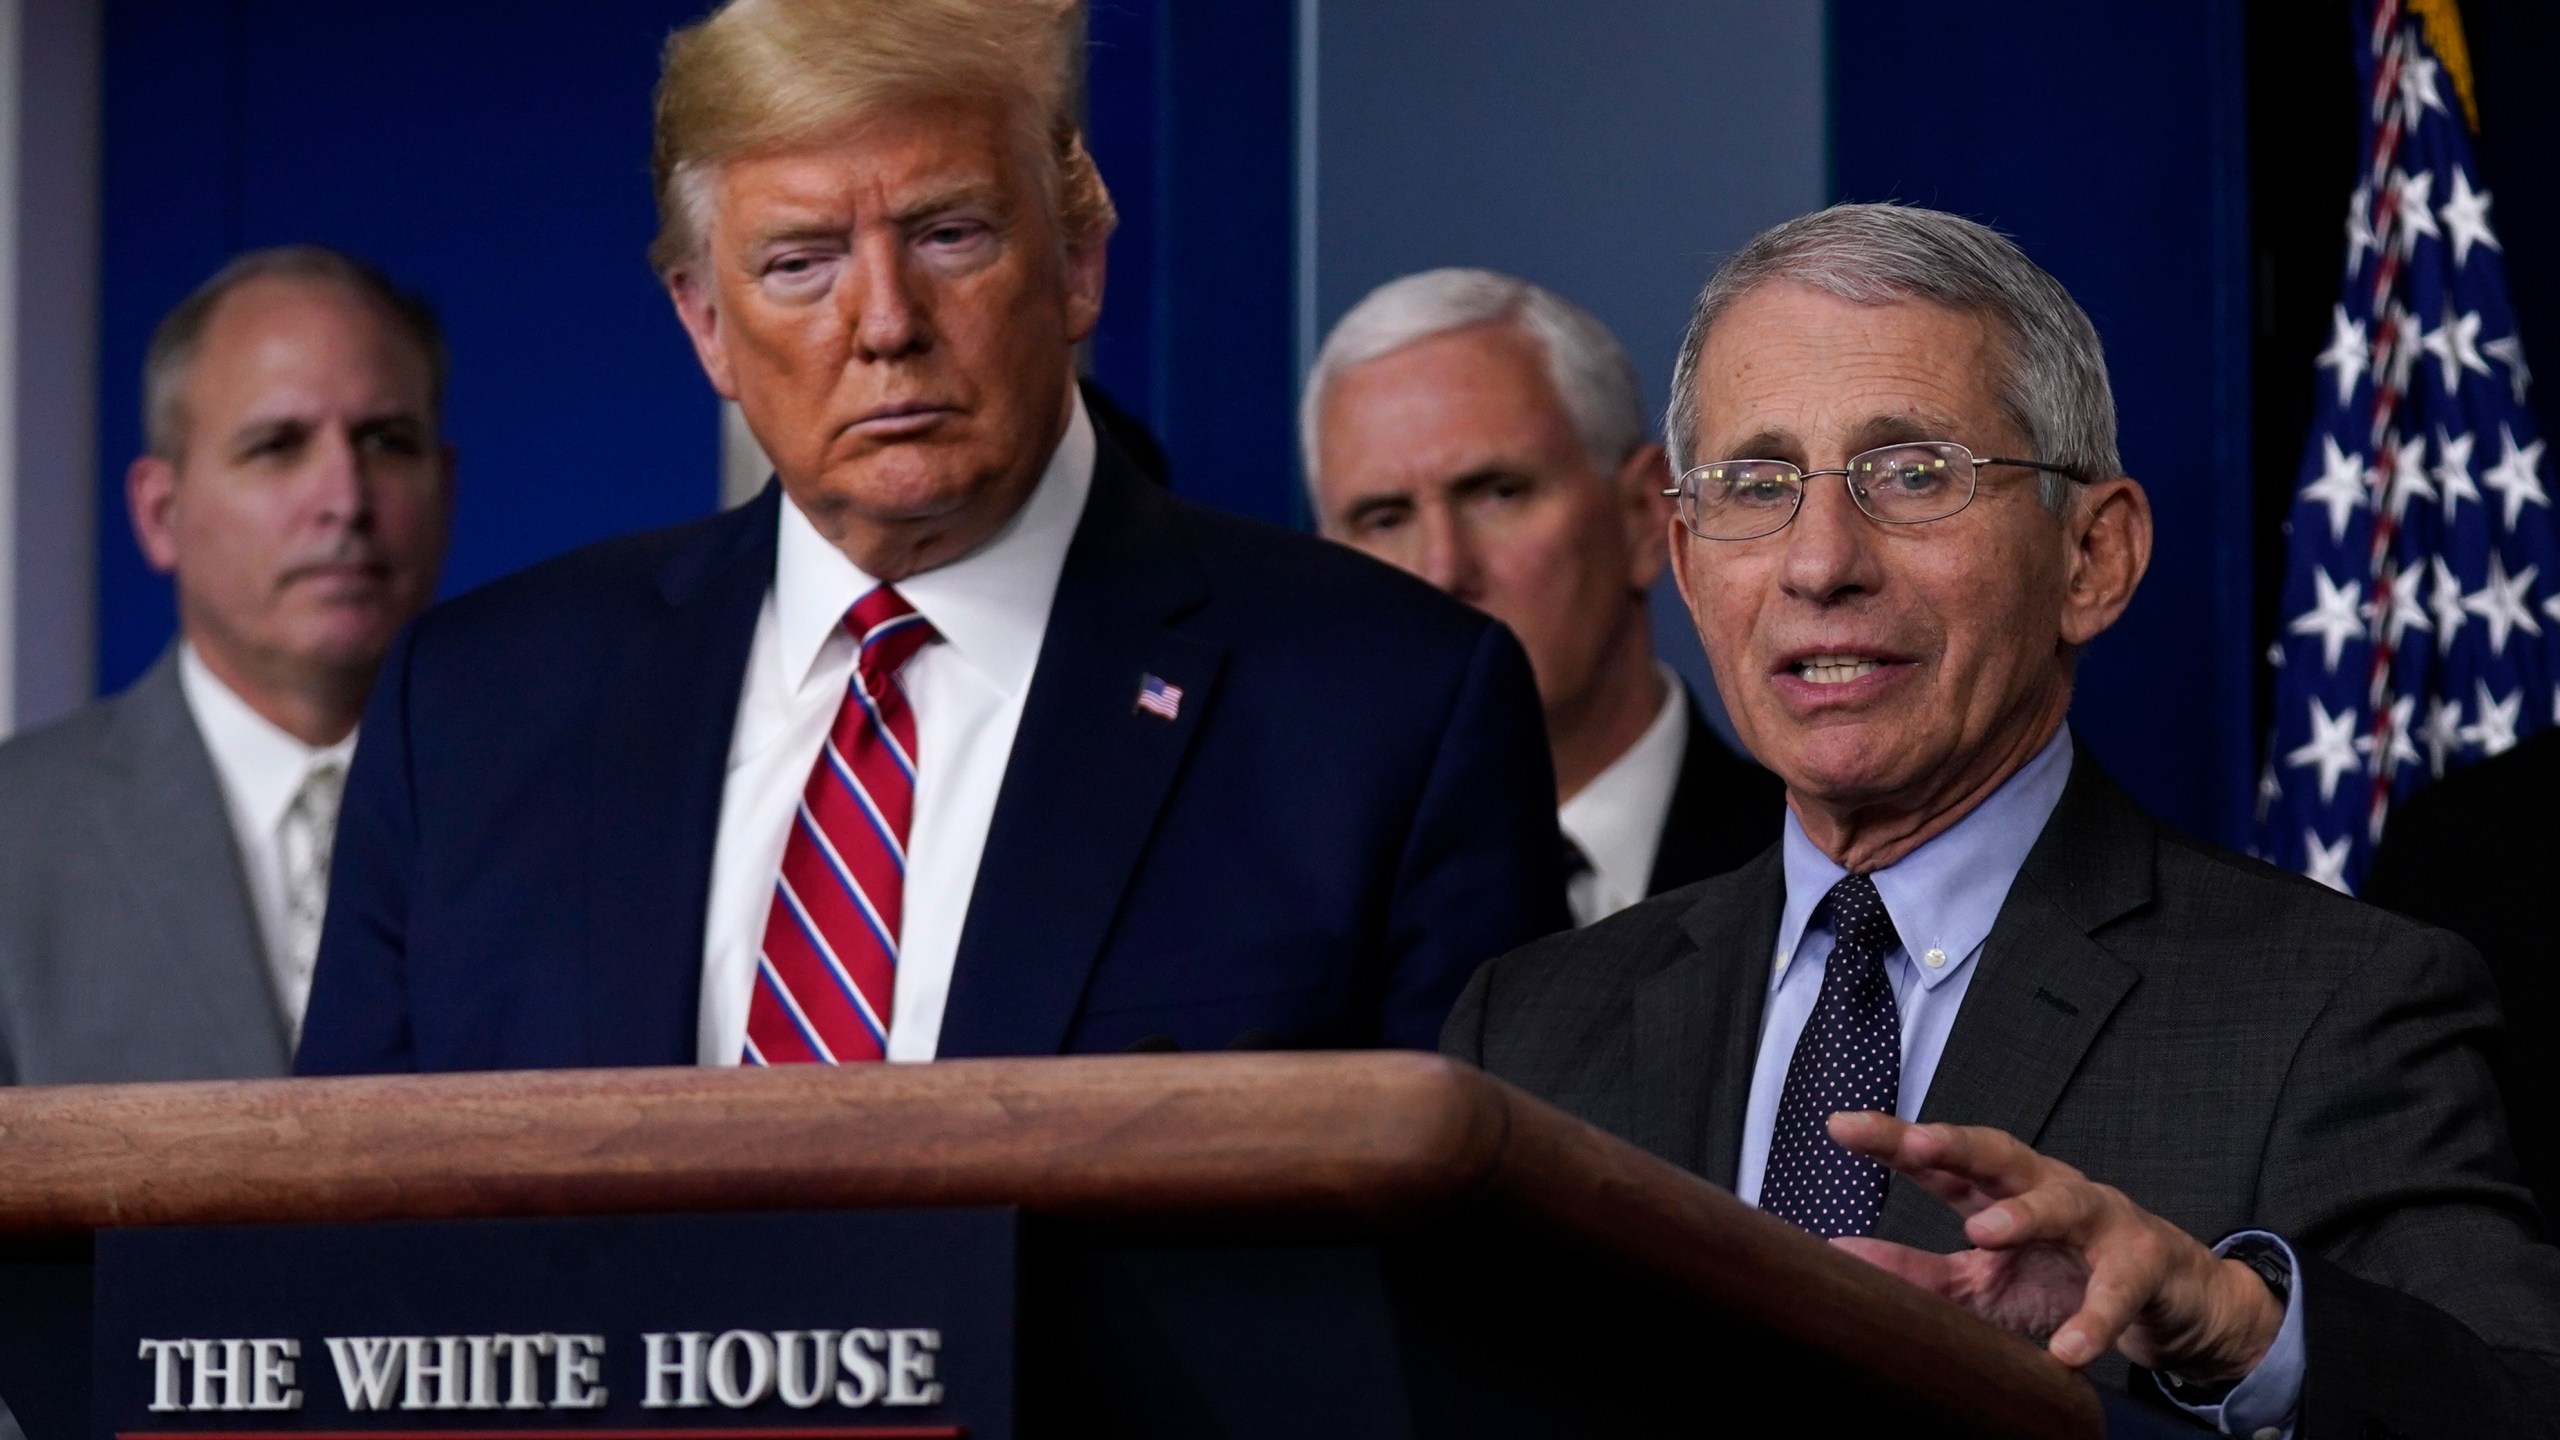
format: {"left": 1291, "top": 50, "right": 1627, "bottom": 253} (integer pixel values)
{"left": 294, "top": 628, "right": 417, "bottom": 1076}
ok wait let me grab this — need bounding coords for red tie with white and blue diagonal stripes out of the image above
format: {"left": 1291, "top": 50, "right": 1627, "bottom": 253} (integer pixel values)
{"left": 742, "top": 584, "right": 934, "bottom": 1066}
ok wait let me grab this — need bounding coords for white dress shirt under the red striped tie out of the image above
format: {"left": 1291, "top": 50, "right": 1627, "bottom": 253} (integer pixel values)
{"left": 696, "top": 397, "right": 1093, "bottom": 1066}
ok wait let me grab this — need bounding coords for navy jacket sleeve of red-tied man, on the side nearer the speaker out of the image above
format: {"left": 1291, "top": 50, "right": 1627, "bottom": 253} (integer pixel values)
{"left": 1377, "top": 625, "right": 1572, "bottom": 1051}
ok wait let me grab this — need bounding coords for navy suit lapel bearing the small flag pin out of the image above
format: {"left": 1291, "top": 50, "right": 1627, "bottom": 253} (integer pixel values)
{"left": 940, "top": 438, "right": 1226, "bottom": 1056}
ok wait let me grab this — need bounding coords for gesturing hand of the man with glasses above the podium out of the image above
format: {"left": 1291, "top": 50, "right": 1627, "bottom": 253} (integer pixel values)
{"left": 1830, "top": 1112, "right": 2284, "bottom": 1384}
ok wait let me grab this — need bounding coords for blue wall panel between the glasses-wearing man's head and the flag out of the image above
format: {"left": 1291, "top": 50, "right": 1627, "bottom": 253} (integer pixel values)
{"left": 1830, "top": 0, "right": 2258, "bottom": 846}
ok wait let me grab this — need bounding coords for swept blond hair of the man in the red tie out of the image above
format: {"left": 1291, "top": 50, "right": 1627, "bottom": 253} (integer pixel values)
{"left": 648, "top": 0, "right": 1119, "bottom": 277}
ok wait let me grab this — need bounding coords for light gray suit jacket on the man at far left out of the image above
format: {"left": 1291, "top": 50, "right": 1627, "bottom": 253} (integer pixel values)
{"left": 0, "top": 651, "right": 292, "bottom": 1084}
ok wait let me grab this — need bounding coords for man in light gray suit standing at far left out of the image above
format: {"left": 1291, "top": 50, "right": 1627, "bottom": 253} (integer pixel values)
{"left": 0, "top": 246, "right": 453, "bottom": 1084}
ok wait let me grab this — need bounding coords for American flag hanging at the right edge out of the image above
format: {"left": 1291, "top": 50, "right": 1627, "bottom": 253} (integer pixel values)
{"left": 2258, "top": 0, "right": 2560, "bottom": 892}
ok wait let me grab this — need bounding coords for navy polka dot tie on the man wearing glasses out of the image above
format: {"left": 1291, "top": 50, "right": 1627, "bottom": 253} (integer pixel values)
{"left": 1761, "top": 874, "right": 1902, "bottom": 1240}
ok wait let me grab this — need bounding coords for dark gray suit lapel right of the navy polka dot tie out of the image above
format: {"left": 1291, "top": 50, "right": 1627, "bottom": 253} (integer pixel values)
{"left": 1876, "top": 753, "right": 2158, "bottom": 1250}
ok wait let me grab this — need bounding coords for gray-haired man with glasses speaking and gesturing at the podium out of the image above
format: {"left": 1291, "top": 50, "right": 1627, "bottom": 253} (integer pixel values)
{"left": 1444, "top": 205, "right": 2560, "bottom": 1440}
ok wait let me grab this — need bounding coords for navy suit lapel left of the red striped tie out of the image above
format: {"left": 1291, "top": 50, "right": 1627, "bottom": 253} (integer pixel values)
{"left": 584, "top": 484, "right": 781, "bottom": 1066}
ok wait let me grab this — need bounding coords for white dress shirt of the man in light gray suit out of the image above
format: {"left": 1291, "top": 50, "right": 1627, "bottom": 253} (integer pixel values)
{"left": 177, "top": 643, "right": 356, "bottom": 1035}
